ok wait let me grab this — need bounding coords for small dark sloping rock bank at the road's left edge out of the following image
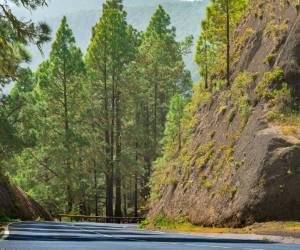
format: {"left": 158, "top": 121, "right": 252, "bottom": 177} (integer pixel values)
{"left": 0, "top": 174, "right": 51, "bottom": 220}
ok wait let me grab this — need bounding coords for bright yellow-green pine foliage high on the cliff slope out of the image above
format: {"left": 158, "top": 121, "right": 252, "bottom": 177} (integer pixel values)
{"left": 195, "top": 0, "right": 248, "bottom": 88}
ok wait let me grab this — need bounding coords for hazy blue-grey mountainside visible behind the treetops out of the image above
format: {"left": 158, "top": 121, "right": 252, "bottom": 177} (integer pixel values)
{"left": 15, "top": 0, "right": 209, "bottom": 81}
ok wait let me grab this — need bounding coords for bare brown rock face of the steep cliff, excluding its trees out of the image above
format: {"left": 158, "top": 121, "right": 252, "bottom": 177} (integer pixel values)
{"left": 149, "top": 0, "right": 300, "bottom": 227}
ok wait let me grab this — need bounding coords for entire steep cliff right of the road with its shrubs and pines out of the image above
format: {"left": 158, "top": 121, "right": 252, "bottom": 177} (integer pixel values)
{"left": 149, "top": 1, "right": 300, "bottom": 226}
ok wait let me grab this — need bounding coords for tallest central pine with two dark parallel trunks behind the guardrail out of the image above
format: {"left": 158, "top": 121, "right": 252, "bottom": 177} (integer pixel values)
{"left": 86, "top": 0, "right": 136, "bottom": 217}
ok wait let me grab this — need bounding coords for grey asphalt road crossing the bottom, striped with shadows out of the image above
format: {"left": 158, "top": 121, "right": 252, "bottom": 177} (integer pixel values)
{"left": 0, "top": 222, "right": 300, "bottom": 250}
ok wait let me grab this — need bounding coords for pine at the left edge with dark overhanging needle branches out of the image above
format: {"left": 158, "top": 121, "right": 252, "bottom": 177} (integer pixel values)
{"left": 0, "top": 0, "right": 50, "bottom": 175}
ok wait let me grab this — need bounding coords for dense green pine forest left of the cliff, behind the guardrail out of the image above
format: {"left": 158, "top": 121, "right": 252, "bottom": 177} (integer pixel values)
{"left": 1, "top": 0, "right": 192, "bottom": 217}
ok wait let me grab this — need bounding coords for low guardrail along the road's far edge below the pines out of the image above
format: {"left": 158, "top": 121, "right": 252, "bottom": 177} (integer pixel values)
{"left": 53, "top": 214, "right": 145, "bottom": 224}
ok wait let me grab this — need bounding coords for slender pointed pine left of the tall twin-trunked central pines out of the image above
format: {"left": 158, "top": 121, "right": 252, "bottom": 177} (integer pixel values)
{"left": 37, "top": 17, "right": 84, "bottom": 212}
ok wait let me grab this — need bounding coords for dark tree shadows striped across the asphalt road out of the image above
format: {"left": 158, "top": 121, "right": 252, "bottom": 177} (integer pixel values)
{"left": 6, "top": 222, "right": 272, "bottom": 244}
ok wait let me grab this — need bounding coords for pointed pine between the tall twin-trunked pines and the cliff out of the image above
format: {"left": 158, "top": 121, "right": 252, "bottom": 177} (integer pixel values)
{"left": 137, "top": 6, "right": 191, "bottom": 197}
